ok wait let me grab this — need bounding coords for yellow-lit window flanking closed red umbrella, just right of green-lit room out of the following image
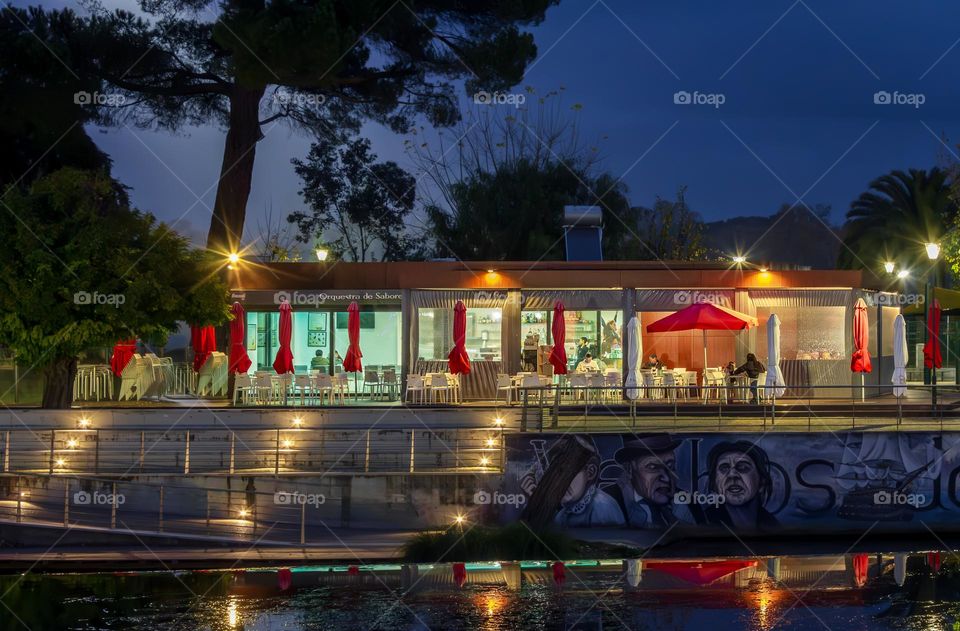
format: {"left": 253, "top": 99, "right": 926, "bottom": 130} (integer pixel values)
{"left": 417, "top": 308, "right": 503, "bottom": 361}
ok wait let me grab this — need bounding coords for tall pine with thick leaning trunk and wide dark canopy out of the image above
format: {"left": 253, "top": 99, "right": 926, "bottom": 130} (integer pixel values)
{"left": 14, "top": 0, "right": 558, "bottom": 250}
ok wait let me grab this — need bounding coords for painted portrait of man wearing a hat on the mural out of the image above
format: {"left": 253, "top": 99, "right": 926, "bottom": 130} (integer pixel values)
{"left": 610, "top": 434, "right": 694, "bottom": 529}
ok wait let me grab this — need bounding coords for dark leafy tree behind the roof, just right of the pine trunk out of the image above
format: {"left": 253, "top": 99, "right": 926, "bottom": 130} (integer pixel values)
{"left": 288, "top": 133, "right": 418, "bottom": 261}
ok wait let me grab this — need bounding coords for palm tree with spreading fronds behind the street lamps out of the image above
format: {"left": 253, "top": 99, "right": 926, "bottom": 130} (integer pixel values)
{"left": 839, "top": 168, "right": 957, "bottom": 271}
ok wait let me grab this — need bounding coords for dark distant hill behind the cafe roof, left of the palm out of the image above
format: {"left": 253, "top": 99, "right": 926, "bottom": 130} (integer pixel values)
{"left": 703, "top": 204, "right": 843, "bottom": 269}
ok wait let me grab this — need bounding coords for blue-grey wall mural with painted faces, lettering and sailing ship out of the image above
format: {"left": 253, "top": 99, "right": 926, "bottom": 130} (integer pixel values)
{"left": 492, "top": 432, "right": 960, "bottom": 534}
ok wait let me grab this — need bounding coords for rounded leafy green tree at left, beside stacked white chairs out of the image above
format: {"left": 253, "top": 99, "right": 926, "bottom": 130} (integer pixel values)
{"left": 0, "top": 168, "right": 228, "bottom": 408}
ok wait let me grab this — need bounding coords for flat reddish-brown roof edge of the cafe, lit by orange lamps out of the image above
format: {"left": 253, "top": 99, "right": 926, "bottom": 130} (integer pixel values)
{"left": 228, "top": 260, "right": 883, "bottom": 291}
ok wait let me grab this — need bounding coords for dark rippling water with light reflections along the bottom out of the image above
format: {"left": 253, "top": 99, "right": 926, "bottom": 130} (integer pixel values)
{"left": 0, "top": 563, "right": 960, "bottom": 631}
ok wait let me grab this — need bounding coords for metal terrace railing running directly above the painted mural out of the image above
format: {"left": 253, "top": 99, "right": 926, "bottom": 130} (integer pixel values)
{"left": 517, "top": 384, "right": 960, "bottom": 431}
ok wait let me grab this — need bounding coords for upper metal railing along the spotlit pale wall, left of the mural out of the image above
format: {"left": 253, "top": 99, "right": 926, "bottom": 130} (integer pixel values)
{"left": 0, "top": 427, "right": 504, "bottom": 476}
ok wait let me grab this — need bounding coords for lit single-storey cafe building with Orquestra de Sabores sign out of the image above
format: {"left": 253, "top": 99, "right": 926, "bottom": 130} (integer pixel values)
{"left": 230, "top": 261, "right": 896, "bottom": 399}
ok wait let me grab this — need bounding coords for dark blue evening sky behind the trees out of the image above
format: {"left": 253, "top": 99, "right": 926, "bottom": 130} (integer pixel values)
{"left": 20, "top": 0, "right": 960, "bottom": 247}
